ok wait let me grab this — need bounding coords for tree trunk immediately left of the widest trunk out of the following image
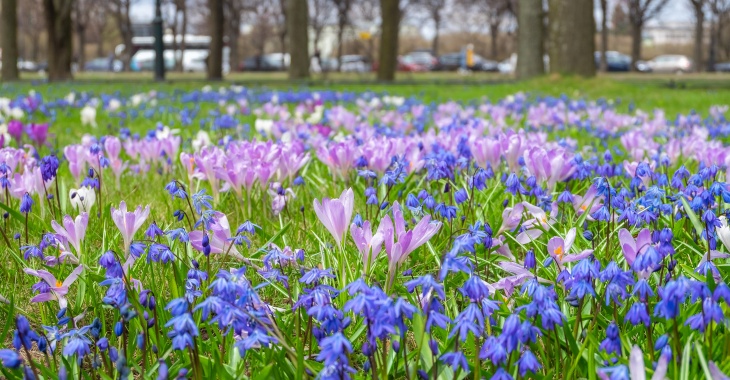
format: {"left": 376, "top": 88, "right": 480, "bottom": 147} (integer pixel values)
{"left": 515, "top": 0, "right": 545, "bottom": 79}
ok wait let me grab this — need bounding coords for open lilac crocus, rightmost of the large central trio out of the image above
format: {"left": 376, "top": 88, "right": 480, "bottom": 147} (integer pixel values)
{"left": 380, "top": 202, "right": 441, "bottom": 274}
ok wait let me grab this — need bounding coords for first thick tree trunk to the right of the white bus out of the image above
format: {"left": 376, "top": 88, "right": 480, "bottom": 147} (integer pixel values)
{"left": 286, "top": 0, "right": 309, "bottom": 79}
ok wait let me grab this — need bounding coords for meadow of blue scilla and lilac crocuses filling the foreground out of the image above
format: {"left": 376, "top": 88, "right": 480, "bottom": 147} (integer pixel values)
{"left": 0, "top": 86, "right": 730, "bottom": 379}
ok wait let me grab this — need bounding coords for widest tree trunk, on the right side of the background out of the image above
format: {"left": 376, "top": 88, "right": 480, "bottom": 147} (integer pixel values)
{"left": 548, "top": 0, "right": 596, "bottom": 77}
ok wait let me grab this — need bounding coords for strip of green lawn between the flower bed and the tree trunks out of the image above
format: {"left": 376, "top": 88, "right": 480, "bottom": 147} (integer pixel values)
{"left": 0, "top": 72, "right": 730, "bottom": 117}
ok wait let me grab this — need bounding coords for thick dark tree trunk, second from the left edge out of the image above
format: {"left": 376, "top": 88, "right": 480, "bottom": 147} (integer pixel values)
{"left": 43, "top": 0, "right": 73, "bottom": 82}
